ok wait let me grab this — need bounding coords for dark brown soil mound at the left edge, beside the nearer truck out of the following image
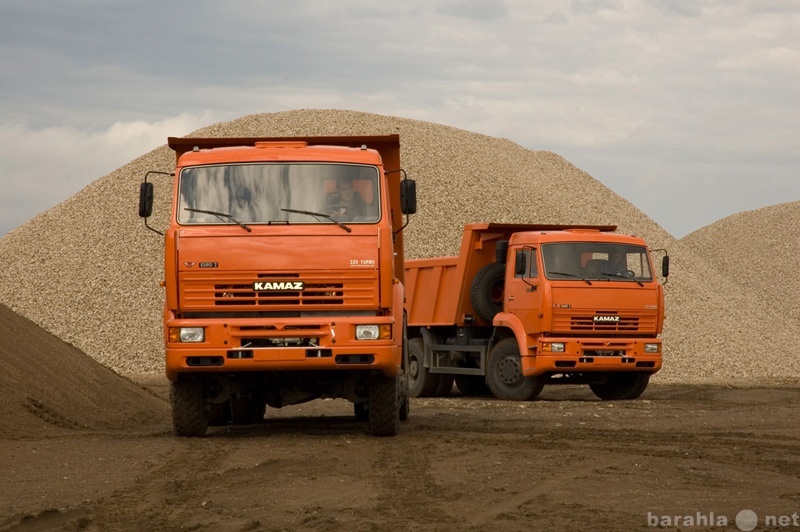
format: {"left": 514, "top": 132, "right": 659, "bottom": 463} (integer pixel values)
{"left": 0, "top": 305, "right": 169, "bottom": 439}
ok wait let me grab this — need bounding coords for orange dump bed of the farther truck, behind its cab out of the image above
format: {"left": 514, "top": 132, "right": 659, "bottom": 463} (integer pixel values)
{"left": 405, "top": 223, "right": 616, "bottom": 327}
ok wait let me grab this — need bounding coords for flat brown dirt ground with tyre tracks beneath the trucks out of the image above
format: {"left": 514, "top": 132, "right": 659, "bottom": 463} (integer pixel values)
{"left": 0, "top": 378, "right": 800, "bottom": 531}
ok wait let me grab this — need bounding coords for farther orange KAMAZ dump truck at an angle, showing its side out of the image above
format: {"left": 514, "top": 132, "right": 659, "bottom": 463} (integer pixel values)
{"left": 405, "top": 223, "right": 669, "bottom": 400}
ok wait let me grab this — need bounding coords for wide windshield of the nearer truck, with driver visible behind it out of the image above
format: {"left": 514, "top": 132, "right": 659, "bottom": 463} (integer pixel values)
{"left": 177, "top": 163, "right": 380, "bottom": 224}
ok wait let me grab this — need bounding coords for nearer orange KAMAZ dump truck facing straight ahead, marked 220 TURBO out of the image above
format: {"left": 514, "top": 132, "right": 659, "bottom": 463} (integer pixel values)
{"left": 139, "top": 135, "right": 416, "bottom": 436}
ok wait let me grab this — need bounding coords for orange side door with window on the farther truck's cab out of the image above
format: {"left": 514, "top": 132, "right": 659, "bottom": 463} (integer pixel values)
{"left": 504, "top": 246, "right": 543, "bottom": 333}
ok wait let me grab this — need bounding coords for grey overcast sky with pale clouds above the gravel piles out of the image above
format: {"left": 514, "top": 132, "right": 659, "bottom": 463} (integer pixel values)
{"left": 0, "top": 0, "right": 800, "bottom": 238}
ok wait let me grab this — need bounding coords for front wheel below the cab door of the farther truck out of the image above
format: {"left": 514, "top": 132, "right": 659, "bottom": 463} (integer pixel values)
{"left": 486, "top": 338, "right": 544, "bottom": 401}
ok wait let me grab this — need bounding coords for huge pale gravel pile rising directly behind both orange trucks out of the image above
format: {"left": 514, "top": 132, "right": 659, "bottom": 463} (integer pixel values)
{"left": 0, "top": 110, "right": 800, "bottom": 383}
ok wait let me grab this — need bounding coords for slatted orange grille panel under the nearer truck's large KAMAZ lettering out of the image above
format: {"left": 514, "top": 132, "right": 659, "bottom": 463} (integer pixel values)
{"left": 181, "top": 271, "right": 378, "bottom": 310}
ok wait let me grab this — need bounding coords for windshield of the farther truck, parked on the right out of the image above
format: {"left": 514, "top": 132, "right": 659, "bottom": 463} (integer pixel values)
{"left": 542, "top": 242, "right": 653, "bottom": 282}
